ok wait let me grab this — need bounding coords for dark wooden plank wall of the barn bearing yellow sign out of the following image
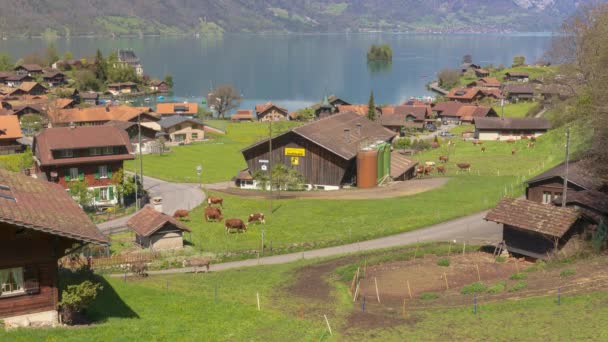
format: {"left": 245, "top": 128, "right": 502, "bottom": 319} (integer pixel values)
{"left": 243, "top": 132, "right": 356, "bottom": 186}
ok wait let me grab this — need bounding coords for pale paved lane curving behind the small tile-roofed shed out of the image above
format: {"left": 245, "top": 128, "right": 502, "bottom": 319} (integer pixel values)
{"left": 97, "top": 176, "right": 205, "bottom": 232}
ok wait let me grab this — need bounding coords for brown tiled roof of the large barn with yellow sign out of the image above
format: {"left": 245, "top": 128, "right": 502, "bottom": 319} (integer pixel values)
{"left": 242, "top": 112, "right": 395, "bottom": 160}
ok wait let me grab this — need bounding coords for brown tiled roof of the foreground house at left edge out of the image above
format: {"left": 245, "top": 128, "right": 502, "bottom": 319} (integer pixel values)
{"left": 0, "top": 170, "right": 108, "bottom": 245}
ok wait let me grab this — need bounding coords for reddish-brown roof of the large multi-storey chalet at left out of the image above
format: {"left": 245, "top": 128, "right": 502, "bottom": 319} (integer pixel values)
{"left": 34, "top": 125, "right": 135, "bottom": 166}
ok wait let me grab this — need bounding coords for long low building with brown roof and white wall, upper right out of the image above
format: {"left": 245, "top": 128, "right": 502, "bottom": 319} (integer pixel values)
{"left": 473, "top": 118, "right": 551, "bottom": 140}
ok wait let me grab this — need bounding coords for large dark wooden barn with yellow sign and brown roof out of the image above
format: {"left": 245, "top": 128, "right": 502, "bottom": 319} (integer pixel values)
{"left": 237, "top": 112, "right": 395, "bottom": 190}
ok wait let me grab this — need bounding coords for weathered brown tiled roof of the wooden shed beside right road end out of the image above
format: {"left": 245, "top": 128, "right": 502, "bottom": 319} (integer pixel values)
{"left": 485, "top": 198, "right": 579, "bottom": 238}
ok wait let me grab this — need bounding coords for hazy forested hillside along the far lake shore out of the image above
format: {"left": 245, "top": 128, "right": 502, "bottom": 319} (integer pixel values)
{"left": 0, "top": 0, "right": 592, "bottom": 36}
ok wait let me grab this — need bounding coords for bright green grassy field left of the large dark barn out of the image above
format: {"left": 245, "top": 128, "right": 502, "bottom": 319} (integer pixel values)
{"left": 125, "top": 121, "right": 300, "bottom": 183}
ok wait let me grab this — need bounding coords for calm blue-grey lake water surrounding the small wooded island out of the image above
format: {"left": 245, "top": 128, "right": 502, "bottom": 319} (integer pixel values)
{"left": 0, "top": 33, "right": 551, "bottom": 110}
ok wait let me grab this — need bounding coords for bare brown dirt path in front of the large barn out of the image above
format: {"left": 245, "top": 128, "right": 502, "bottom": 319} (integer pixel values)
{"left": 216, "top": 177, "right": 449, "bottom": 200}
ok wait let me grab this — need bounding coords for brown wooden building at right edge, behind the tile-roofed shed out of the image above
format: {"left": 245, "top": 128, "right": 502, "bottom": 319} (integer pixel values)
{"left": 526, "top": 162, "right": 602, "bottom": 204}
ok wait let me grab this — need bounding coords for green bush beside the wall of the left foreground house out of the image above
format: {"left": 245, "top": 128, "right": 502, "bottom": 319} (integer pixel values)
{"left": 59, "top": 280, "right": 103, "bottom": 324}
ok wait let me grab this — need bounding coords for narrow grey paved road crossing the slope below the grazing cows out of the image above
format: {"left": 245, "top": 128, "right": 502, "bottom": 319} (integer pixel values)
{"left": 114, "top": 211, "right": 502, "bottom": 276}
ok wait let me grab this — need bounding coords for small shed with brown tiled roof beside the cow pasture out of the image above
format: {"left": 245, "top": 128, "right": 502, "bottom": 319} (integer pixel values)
{"left": 127, "top": 205, "right": 191, "bottom": 251}
